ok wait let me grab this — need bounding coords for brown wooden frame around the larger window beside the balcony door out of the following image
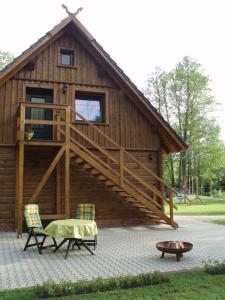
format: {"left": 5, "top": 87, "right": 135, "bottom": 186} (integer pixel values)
{"left": 72, "top": 88, "right": 109, "bottom": 125}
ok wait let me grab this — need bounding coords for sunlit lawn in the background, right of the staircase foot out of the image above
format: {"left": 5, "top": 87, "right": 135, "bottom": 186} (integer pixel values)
{"left": 165, "top": 197, "right": 225, "bottom": 216}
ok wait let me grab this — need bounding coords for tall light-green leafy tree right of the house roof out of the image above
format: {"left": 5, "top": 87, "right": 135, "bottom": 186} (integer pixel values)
{"left": 144, "top": 57, "right": 222, "bottom": 191}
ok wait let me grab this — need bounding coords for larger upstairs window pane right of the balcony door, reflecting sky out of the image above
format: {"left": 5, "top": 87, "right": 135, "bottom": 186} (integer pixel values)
{"left": 75, "top": 92, "right": 105, "bottom": 123}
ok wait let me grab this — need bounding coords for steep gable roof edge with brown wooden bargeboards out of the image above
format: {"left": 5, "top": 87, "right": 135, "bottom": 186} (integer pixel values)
{"left": 0, "top": 15, "right": 187, "bottom": 153}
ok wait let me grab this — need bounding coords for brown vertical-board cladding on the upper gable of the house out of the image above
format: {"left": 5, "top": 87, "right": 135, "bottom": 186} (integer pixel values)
{"left": 0, "top": 31, "right": 160, "bottom": 149}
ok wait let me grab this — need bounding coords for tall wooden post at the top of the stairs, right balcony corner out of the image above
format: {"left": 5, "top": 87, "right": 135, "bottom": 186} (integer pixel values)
{"left": 65, "top": 108, "right": 70, "bottom": 218}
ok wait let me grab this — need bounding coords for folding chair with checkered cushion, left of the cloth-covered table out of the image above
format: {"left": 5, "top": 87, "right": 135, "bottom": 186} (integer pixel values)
{"left": 24, "top": 204, "right": 57, "bottom": 254}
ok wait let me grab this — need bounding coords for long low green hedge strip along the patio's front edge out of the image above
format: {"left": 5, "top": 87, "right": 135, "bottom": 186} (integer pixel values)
{"left": 36, "top": 272, "right": 169, "bottom": 298}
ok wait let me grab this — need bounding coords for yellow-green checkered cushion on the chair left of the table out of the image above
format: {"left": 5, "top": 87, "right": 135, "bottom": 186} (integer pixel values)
{"left": 24, "top": 204, "right": 43, "bottom": 229}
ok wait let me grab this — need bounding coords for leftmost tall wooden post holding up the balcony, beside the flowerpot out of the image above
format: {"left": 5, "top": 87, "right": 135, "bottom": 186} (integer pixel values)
{"left": 16, "top": 104, "right": 25, "bottom": 237}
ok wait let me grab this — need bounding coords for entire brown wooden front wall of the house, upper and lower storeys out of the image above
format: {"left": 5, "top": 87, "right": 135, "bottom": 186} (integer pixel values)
{"left": 0, "top": 28, "right": 161, "bottom": 228}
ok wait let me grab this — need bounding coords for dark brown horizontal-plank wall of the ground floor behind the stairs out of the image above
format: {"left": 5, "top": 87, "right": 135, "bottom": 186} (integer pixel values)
{"left": 0, "top": 147, "right": 160, "bottom": 230}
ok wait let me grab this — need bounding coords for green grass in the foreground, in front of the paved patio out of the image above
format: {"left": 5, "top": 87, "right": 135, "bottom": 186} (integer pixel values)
{"left": 0, "top": 271, "right": 225, "bottom": 300}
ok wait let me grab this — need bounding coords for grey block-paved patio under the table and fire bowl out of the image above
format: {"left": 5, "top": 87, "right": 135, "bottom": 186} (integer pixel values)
{"left": 0, "top": 217, "right": 225, "bottom": 289}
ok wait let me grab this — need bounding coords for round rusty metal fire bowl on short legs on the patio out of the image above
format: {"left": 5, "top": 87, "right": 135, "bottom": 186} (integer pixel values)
{"left": 156, "top": 241, "right": 193, "bottom": 261}
